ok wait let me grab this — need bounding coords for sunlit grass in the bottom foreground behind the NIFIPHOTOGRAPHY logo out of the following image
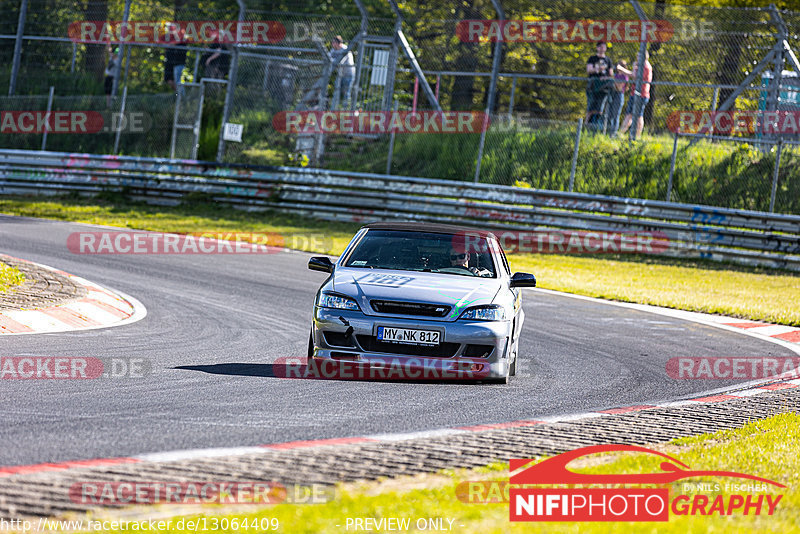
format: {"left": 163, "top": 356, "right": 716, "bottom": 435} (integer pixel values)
{"left": 97, "top": 413, "right": 800, "bottom": 534}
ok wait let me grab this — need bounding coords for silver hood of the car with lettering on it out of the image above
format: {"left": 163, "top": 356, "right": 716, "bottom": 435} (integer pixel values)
{"left": 331, "top": 267, "right": 500, "bottom": 319}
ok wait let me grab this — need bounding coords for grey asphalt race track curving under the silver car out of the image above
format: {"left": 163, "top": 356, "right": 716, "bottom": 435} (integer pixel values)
{"left": 0, "top": 215, "right": 794, "bottom": 466}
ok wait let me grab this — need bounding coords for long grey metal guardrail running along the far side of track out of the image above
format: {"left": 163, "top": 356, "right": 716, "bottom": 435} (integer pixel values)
{"left": 0, "top": 150, "right": 800, "bottom": 270}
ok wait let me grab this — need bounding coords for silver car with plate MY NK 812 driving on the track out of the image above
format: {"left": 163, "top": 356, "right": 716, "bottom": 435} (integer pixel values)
{"left": 308, "top": 223, "right": 536, "bottom": 383}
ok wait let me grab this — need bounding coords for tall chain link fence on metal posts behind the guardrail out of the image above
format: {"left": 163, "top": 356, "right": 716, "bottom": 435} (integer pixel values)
{"left": 0, "top": 0, "right": 800, "bottom": 213}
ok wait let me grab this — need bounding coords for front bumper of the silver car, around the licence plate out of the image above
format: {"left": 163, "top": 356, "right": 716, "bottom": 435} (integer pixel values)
{"left": 312, "top": 306, "right": 511, "bottom": 380}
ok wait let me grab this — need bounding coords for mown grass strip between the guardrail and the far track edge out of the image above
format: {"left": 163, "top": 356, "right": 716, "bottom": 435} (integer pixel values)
{"left": 0, "top": 197, "right": 800, "bottom": 325}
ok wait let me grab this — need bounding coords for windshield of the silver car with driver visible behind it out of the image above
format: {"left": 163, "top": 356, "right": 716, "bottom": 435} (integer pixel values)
{"left": 345, "top": 230, "right": 497, "bottom": 278}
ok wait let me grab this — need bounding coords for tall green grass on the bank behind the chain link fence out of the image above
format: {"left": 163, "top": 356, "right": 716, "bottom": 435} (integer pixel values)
{"left": 237, "top": 125, "right": 800, "bottom": 214}
